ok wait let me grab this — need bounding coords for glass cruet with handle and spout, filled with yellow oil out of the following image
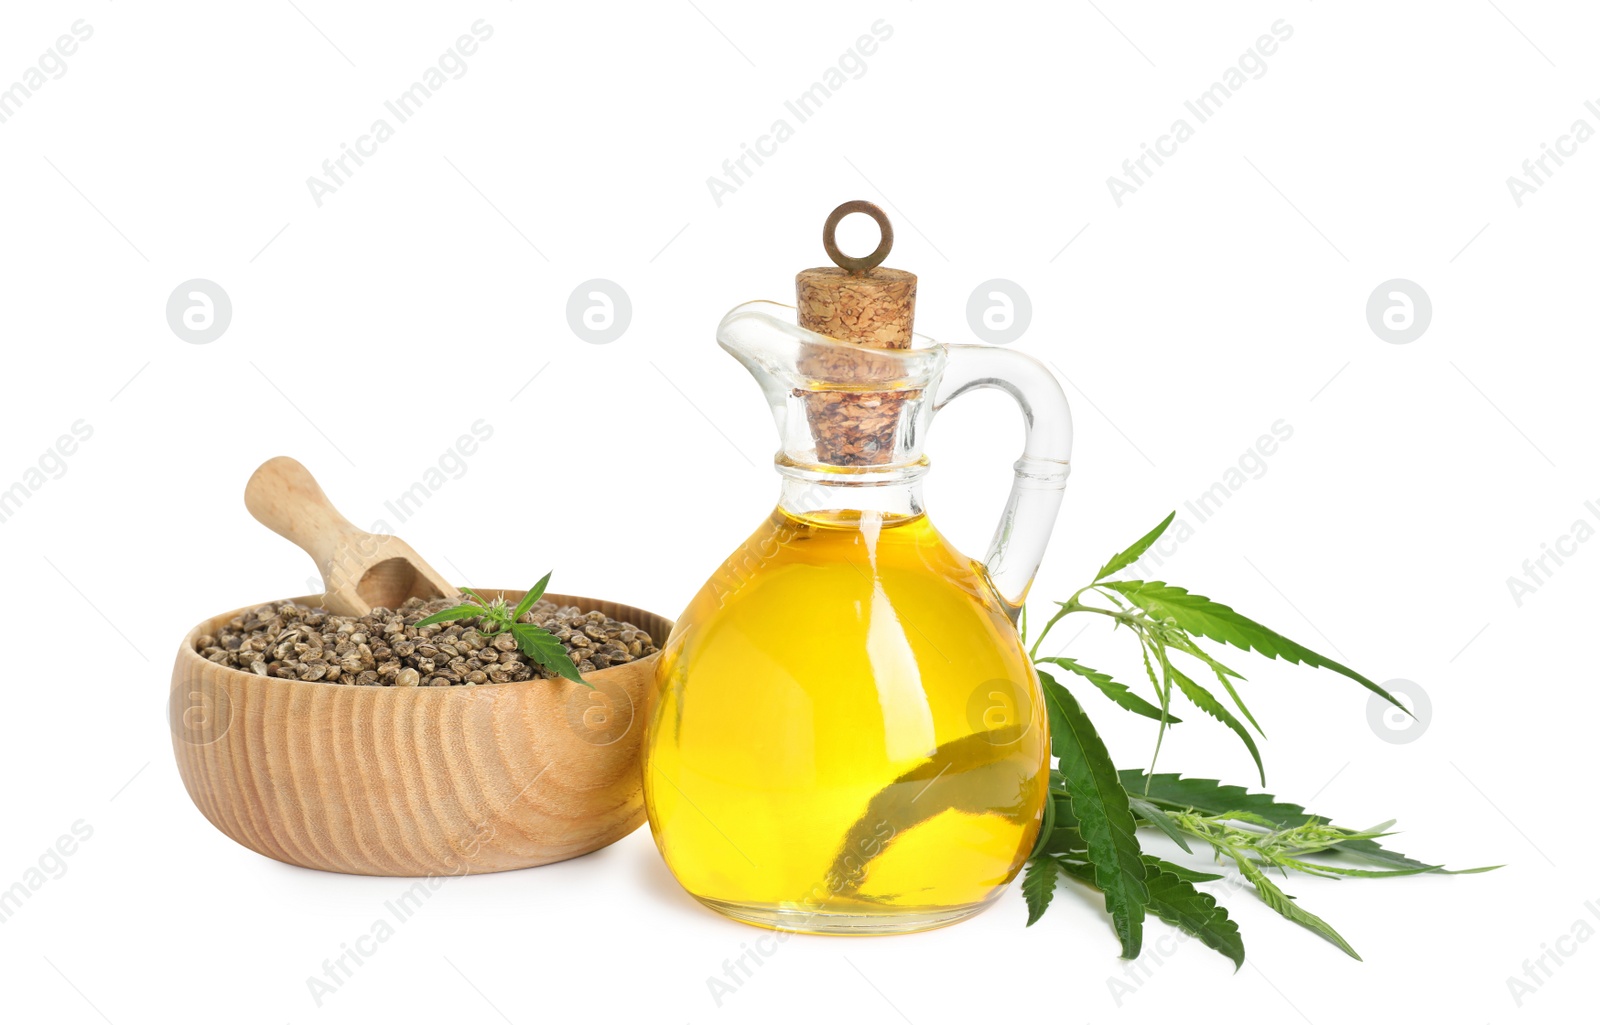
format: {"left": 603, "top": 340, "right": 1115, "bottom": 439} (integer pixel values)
{"left": 645, "top": 205, "right": 1072, "bottom": 934}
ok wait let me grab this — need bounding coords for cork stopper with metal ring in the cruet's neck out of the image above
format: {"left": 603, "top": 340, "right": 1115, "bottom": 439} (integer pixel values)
{"left": 795, "top": 200, "right": 917, "bottom": 465}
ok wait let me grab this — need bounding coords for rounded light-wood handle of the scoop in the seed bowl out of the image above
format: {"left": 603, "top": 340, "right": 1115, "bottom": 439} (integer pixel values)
{"left": 245, "top": 456, "right": 379, "bottom": 593}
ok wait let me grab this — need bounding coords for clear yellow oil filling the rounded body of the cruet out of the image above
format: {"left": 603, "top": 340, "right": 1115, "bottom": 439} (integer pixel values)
{"left": 645, "top": 509, "right": 1048, "bottom": 932}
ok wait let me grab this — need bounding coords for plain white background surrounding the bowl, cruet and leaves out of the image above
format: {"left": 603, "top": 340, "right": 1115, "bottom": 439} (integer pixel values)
{"left": 0, "top": 0, "right": 1600, "bottom": 1025}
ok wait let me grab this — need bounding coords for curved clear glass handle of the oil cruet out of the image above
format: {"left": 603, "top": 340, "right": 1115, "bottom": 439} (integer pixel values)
{"left": 933, "top": 345, "right": 1072, "bottom": 622}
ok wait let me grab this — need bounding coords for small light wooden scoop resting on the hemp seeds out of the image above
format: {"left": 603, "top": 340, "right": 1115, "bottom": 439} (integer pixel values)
{"left": 245, "top": 456, "right": 459, "bottom": 616}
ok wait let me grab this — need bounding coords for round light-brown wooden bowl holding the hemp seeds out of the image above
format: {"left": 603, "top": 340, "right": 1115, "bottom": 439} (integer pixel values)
{"left": 168, "top": 590, "right": 672, "bottom": 876}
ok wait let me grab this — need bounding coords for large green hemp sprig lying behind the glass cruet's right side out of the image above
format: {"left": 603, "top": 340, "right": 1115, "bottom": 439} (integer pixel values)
{"left": 1022, "top": 513, "right": 1498, "bottom": 967}
